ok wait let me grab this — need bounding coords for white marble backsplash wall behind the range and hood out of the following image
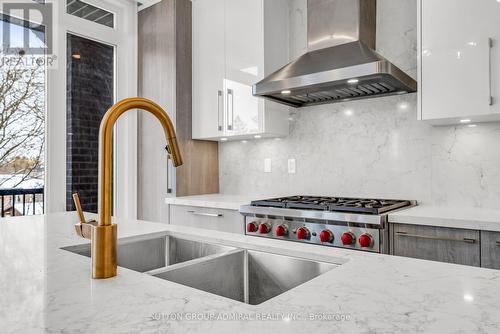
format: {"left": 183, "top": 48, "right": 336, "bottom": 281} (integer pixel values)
{"left": 219, "top": 0, "right": 500, "bottom": 209}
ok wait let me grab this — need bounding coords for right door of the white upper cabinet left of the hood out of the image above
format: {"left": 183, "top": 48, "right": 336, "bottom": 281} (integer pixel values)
{"left": 224, "top": 0, "right": 264, "bottom": 136}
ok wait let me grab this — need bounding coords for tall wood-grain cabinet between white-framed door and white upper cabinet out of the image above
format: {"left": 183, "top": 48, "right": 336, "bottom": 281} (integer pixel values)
{"left": 137, "top": 0, "right": 219, "bottom": 222}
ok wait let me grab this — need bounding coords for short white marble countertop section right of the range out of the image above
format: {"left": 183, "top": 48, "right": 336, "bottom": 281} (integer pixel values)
{"left": 389, "top": 205, "right": 500, "bottom": 232}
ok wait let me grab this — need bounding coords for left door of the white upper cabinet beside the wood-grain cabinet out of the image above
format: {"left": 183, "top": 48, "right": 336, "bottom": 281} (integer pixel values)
{"left": 192, "top": 0, "right": 225, "bottom": 139}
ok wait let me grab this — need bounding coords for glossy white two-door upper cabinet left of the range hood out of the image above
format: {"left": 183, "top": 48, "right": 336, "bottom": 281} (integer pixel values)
{"left": 193, "top": 0, "right": 288, "bottom": 140}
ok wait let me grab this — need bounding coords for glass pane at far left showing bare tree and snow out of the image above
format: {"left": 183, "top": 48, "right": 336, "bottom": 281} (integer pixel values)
{"left": 0, "top": 14, "right": 46, "bottom": 217}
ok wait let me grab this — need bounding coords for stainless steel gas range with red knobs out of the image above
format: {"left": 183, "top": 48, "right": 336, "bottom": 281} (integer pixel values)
{"left": 240, "top": 196, "right": 417, "bottom": 254}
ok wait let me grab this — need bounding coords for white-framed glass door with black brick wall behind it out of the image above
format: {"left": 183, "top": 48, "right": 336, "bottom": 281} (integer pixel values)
{"left": 47, "top": 0, "right": 137, "bottom": 218}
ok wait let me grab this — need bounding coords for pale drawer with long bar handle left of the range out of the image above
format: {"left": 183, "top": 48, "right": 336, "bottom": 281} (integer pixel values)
{"left": 170, "top": 205, "right": 244, "bottom": 234}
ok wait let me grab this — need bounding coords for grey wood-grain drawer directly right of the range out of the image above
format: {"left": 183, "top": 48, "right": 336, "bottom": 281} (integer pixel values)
{"left": 390, "top": 224, "right": 480, "bottom": 266}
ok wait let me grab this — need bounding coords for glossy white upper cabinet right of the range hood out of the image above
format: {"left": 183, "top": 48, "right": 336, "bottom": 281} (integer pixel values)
{"left": 419, "top": 0, "right": 500, "bottom": 125}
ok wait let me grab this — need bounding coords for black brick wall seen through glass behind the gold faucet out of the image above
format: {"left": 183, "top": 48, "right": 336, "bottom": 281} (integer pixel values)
{"left": 66, "top": 34, "right": 114, "bottom": 212}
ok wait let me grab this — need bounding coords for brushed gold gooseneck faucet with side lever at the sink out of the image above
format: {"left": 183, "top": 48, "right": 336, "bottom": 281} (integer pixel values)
{"left": 73, "top": 98, "right": 182, "bottom": 279}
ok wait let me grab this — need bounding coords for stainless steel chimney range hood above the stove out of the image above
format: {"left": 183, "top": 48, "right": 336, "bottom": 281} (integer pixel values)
{"left": 253, "top": 0, "right": 417, "bottom": 108}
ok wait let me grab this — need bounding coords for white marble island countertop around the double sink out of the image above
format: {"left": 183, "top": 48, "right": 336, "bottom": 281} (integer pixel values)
{"left": 0, "top": 212, "right": 500, "bottom": 334}
